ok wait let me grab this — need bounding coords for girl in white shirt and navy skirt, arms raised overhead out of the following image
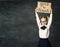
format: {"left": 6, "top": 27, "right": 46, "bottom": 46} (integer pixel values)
{"left": 35, "top": 10, "right": 52, "bottom": 47}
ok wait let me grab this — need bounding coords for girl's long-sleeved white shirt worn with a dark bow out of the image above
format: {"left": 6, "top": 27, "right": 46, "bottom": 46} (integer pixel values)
{"left": 35, "top": 13, "right": 52, "bottom": 38}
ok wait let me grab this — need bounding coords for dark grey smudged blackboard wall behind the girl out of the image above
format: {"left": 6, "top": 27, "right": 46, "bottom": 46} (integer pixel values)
{"left": 0, "top": 0, "right": 60, "bottom": 47}
